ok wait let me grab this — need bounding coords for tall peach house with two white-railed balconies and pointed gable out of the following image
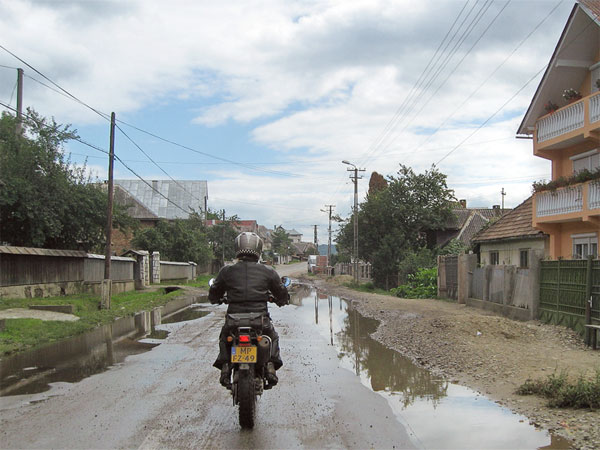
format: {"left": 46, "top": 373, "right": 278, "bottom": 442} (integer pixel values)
{"left": 518, "top": 0, "right": 600, "bottom": 259}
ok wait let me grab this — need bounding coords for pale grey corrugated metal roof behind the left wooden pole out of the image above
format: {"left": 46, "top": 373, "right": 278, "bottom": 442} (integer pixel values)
{"left": 114, "top": 180, "right": 208, "bottom": 220}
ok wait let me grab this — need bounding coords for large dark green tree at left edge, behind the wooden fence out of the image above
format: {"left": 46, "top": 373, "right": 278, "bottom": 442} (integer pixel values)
{"left": 0, "top": 109, "right": 132, "bottom": 251}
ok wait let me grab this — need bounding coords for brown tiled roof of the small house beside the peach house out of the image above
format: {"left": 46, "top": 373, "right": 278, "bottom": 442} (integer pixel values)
{"left": 473, "top": 197, "right": 546, "bottom": 242}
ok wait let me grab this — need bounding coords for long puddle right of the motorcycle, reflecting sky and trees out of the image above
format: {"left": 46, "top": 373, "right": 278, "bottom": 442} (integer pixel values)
{"left": 292, "top": 287, "right": 571, "bottom": 449}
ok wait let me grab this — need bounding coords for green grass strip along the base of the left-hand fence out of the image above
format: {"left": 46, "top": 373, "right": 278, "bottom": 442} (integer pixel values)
{"left": 0, "top": 289, "right": 181, "bottom": 355}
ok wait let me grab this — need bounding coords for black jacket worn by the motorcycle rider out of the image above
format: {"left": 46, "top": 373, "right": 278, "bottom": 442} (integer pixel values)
{"left": 208, "top": 259, "right": 289, "bottom": 313}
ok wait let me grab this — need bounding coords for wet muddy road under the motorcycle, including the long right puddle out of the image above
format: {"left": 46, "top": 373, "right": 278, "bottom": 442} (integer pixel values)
{"left": 0, "top": 276, "right": 566, "bottom": 448}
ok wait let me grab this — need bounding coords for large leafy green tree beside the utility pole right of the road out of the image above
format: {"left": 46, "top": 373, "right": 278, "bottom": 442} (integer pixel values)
{"left": 336, "top": 165, "right": 454, "bottom": 289}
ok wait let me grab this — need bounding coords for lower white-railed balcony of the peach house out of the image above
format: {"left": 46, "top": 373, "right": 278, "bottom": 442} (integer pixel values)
{"left": 533, "top": 180, "right": 600, "bottom": 226}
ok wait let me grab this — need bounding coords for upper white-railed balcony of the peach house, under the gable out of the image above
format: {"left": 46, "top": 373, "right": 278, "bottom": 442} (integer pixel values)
{"left": 534, "top": 92, "right": 600, "bottom": 157}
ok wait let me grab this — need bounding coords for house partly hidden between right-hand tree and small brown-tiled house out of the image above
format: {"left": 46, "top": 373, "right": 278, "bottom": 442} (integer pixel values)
{"left": 426, "top": 200, "right": 510, "bottom": 248}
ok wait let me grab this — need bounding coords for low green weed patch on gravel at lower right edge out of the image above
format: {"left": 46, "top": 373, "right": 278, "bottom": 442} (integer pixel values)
{"left": 517, "top": 369, "right": 600, "bottom": 409}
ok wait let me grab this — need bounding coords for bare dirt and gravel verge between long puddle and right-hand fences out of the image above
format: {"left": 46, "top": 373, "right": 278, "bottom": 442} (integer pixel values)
{"left": 316, "top": 280, "right": 600, "bottom": 448}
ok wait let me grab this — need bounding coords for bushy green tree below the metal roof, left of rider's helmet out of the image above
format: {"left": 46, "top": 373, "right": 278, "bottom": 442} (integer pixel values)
{"left": 131, "top": 213, "right": 213, "bottom": 264}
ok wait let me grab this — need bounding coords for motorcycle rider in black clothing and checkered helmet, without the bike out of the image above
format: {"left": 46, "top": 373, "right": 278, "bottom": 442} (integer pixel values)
{"left": 208, "top": 232, "right": 289, "bottom": 388}
